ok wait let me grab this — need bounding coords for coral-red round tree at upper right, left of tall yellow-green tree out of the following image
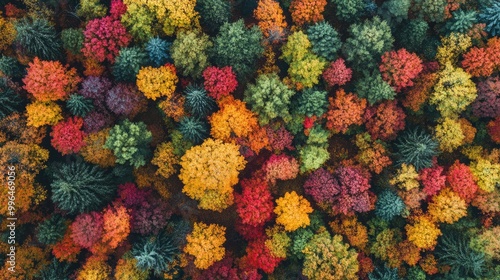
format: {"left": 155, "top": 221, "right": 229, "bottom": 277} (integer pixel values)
{"left": 379, "top": 49, "right": 423, "bottom": 92}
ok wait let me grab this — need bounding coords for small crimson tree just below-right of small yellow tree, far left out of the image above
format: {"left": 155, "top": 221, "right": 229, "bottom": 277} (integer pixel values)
{"left": 50, "top": 117, "right": 86, "bottom": 155}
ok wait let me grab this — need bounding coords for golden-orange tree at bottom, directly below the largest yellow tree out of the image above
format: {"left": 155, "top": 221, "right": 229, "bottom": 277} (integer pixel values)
{"left": 184, "top": 222, "right": 226, "bottom": 269}
